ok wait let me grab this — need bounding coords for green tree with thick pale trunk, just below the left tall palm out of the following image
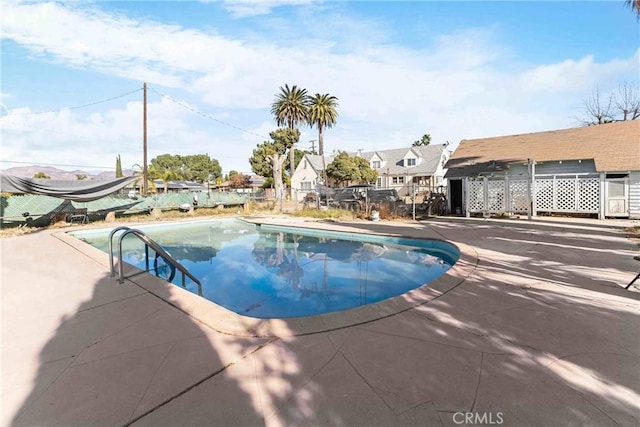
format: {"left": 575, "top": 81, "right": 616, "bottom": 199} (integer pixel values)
{"left": 249, "top": 128, "right": 300, "bottom": 206}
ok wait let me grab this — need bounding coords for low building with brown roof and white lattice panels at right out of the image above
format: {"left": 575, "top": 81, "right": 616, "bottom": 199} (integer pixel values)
{"left": 445, "top": 120, "right": 640, "bottom": 219}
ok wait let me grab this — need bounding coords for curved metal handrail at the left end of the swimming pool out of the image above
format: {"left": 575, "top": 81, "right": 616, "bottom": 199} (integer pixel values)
{"left": 109, "top": 226, "right": 202, "bottom": 295}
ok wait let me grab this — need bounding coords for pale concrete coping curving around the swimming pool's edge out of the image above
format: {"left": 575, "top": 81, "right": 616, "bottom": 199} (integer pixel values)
{"left": 53, "top": 217, "right": 478, "bottom": 338}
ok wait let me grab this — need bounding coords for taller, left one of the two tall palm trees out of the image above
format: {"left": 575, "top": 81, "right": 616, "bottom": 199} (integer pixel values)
{"left": 271, "top": 84, "right": 309, "bottom": 176}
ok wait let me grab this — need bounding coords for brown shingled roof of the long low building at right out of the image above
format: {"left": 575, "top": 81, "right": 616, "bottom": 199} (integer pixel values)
{"left": 445, "top": 120, "right": 640, "bottom": 178}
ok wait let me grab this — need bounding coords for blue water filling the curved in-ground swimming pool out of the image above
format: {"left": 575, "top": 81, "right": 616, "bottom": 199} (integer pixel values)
{"left": 72, "top": 219, "right": 460, "bottom": 318}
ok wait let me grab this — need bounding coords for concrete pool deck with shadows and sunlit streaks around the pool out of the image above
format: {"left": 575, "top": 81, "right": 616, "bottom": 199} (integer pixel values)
{"left": 0, "top": 218, "right": 640, "bottom": 426}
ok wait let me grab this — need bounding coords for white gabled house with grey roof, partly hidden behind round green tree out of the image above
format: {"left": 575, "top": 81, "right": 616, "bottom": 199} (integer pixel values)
{"left": 291, "top": 145, "right": 450, "bottom": 195}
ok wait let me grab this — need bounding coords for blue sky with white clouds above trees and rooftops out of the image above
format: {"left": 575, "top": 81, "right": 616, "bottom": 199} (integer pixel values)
{"left": 0, "top": 0, "right": 640, "bottom": 172}
